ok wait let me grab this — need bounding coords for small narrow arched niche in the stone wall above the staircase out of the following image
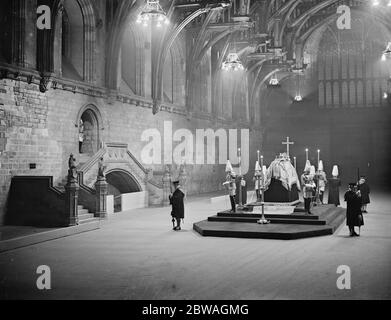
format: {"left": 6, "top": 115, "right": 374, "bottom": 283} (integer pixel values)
{"left": 79, "top": 108, "right": 100, "bottom": 156}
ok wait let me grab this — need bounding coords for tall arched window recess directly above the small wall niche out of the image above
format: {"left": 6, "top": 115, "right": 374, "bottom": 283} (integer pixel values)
{"left": 51, "top": 0, "right": 96, "bottom": 82}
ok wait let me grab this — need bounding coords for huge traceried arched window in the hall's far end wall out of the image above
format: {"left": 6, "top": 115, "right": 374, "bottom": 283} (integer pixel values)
{"left": 316, "top": 11, "right": 391, "bottom": 107}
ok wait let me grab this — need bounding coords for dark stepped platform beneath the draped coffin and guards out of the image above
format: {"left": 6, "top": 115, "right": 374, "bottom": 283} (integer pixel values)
{"left": 193, "top": 205, "right": 346, "bottom": 240}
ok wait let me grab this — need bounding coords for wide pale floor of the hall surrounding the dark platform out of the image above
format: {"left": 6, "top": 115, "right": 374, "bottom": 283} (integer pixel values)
{"left": 0, "top": 192, "right": 391, "bottom": 299}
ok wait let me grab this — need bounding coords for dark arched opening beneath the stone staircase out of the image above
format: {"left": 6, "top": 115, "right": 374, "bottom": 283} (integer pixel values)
{"left": 106, "top": 169, "right": 142, "bottom": 212}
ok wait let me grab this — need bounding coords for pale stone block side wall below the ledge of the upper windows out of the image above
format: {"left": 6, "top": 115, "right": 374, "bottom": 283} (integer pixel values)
{"left": 0, "top": 79, "right": 260, "bottom": 225}
